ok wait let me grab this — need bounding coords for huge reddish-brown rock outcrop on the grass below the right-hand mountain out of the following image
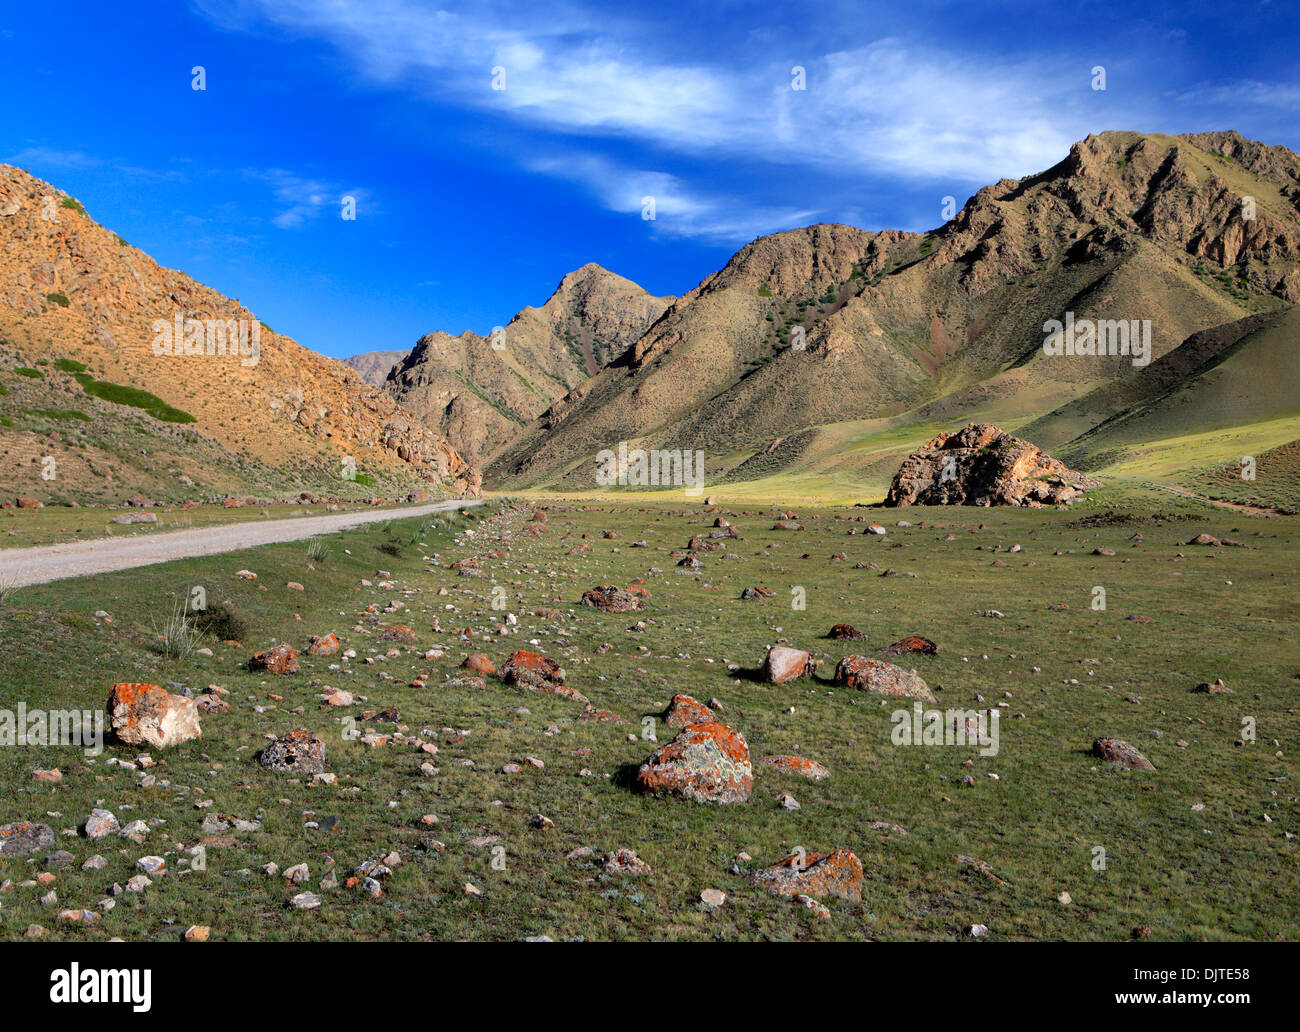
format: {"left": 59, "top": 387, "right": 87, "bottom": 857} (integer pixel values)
{"left": 885, "top": 422, "right": 1101, "bottom": 508}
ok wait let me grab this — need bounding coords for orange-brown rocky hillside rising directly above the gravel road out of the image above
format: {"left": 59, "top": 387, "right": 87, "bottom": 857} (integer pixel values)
{"left": 0, "top": 165, "right": 480, "bottom": 500}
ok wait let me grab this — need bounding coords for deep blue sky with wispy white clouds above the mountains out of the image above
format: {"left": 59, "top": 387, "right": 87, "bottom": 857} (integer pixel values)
{"left": 0, "top": 0, "right": 1300, "bottom": 357}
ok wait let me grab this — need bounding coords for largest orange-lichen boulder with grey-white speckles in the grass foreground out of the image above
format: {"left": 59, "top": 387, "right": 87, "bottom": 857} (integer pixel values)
{"left": 636, "top": 720, "right": 754, "bottom": 803}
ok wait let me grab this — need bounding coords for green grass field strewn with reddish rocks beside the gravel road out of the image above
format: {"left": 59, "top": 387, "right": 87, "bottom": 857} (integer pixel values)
{"left": 0, "top": 491, "right": 1300, "bottom": 940}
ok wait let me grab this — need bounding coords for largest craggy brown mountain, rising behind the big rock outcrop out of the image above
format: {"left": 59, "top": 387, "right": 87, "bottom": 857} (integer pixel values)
{"left": 489, "top": 133, "right": 1300, "bottom": 487}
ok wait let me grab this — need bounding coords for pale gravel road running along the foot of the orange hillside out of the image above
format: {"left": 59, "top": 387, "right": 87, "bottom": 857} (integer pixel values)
{"left": 0, "top": 502, "right": 482, "bottom": 587}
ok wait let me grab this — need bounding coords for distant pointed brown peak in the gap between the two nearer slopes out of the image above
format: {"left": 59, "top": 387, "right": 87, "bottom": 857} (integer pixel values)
{"left": 385, "top": 264, "right": 673, "bottom": 461}
